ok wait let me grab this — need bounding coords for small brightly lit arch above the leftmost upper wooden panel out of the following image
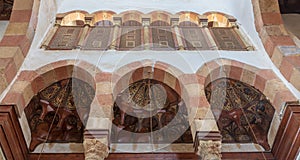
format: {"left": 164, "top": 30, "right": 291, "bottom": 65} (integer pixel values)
{"left": 61, "top": 10, "right": 88, "bottom": 26}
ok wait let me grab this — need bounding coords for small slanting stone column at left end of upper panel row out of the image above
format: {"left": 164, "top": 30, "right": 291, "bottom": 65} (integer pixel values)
{"left": 41, "top": 14, "right": 64, "bottom": 49}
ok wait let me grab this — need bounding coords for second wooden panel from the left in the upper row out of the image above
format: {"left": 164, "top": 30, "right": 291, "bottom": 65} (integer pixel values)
{"left": 82, "top": 26, "right": 113, "bottom": 50}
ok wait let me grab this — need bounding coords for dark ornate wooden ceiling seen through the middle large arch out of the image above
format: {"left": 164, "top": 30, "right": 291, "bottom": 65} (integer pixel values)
{"left": 112, "top": 79, "right": 192, "bottom": 143}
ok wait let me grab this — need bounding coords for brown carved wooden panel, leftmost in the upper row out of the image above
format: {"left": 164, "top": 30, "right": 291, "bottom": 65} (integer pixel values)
{"left": 47, "top": 26, "right": 82, "bottom": 50}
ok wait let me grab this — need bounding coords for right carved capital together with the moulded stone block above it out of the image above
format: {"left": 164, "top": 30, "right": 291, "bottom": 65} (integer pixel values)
{"left": 194, "top": 131, "right": 222, "bottom": 160}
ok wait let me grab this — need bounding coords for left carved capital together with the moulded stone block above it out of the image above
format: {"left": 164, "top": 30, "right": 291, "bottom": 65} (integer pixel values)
{"left": 83, "top": 129, "right": 109, "bottom": 160}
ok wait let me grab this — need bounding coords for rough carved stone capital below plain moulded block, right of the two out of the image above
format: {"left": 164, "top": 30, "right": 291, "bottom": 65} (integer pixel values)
{"left": 197, "top": 140, "right": 222, "bottom": 160}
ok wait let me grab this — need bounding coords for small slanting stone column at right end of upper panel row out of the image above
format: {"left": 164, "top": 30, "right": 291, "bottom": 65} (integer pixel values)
{"left": 228, "top": 18, "right": 255, "bottom": 51}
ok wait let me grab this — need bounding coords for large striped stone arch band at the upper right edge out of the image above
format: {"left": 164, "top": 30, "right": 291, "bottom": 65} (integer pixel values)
{"left": 252, "top": 0, "right": 300, "bottom": 90}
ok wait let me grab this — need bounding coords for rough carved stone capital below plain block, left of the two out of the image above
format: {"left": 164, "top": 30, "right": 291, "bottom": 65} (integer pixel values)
{"left": 83, "top": 137, "right": 109, "bottom": 160}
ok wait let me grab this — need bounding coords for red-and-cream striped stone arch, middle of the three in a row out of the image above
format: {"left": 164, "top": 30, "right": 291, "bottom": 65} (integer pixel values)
{"left": 110, "top": 60, "right": 203, "bottom": 142}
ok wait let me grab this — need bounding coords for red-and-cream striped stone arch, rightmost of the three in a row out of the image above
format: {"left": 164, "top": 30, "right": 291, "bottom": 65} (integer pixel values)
{"left": 197, "top": 59, "right": 297, "bottom": 146}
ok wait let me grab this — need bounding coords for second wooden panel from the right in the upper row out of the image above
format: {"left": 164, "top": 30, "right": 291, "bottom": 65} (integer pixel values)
{"left": 180, "top": 27, "right": 210, "bottom": 50}
